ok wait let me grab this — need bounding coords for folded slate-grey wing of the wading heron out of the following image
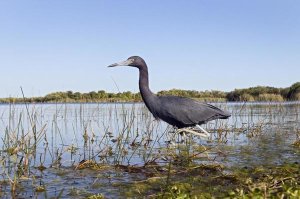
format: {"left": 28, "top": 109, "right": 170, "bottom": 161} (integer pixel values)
{"left": 160, "top": 96, "right": 230, "bottom": 125}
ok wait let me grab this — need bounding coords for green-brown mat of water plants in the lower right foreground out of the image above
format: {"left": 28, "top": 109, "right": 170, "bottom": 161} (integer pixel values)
{"left": 122, "top": 163, "right": 300, "bottom": 199}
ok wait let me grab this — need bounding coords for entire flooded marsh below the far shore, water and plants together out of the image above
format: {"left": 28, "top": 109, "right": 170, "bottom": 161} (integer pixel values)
{"left": 0, "top": 102, "right": 300, "bottom": 198}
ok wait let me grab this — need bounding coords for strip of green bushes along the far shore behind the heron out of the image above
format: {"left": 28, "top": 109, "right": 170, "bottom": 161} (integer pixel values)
{"left": 0, "top": 82, "right": 300, "bottom": 103}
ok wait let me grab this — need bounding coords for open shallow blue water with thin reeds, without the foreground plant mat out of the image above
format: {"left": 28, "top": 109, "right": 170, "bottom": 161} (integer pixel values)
{"left": 0, "top": 102, "right": 300, "bottom": 198}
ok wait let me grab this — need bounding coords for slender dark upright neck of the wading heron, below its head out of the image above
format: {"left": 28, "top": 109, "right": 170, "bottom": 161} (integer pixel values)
{"left": 139, "top": 67, "right": 156, "bottom": 104}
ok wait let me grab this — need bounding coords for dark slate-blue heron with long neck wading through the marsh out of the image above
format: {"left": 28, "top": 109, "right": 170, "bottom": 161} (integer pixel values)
{"left": 108, "top": 56, "right": 231, "bottom": 137}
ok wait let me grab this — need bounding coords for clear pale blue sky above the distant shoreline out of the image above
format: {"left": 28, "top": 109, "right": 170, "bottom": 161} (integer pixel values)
{"left": 0, "top": 0, "right": 300, "bottom": 97}
